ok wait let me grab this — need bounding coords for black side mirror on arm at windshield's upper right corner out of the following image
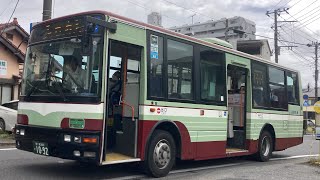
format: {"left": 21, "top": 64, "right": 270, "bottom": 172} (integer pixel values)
{"left": 81, "top": 16, "right": 117, "bottom": 55}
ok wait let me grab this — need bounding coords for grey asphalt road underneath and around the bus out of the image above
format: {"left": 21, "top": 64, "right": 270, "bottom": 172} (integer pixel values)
{"left": 0, "top": 136, "right": 320, "bottom": 180}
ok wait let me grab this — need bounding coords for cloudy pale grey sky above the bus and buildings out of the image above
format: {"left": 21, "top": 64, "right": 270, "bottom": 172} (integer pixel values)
{"left": 0, "top": 0, "right": 320, "bottom": 87}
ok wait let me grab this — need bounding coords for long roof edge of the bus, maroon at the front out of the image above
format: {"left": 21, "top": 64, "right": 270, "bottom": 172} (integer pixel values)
{"left": 34, "top": 10, "right": 298, "bottom": 72}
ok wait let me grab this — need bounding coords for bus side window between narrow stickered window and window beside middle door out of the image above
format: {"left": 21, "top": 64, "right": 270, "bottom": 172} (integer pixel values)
{"left": 167, "top": 39, "right": 194, "bottom": 99}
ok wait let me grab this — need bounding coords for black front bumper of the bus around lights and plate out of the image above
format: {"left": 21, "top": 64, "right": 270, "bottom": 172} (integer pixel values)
{"left": 15, "top": 125, "right": 101, "bottom": 163}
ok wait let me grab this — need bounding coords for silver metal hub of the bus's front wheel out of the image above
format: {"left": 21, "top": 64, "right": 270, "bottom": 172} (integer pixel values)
{"left": 153, "top": 139, "right": 171, "bottom": 169}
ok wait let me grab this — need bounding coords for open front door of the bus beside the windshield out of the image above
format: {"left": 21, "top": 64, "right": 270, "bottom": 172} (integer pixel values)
{"left": 105, "top": 40, "right": 142, "bottom": 164}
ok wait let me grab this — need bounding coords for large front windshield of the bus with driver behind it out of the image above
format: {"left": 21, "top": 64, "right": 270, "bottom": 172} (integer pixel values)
{"left": 22, "top": 37, "right": 102, "bottom": 100}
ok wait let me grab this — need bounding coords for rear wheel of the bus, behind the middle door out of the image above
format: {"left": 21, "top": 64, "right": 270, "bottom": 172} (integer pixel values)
{"left": 256, "top": 131, "right": 273, "bottom": 162}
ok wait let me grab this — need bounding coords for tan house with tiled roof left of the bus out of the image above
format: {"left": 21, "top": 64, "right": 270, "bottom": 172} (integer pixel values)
{"left": 0, "top": 18, "right": 29, "bottom": 104}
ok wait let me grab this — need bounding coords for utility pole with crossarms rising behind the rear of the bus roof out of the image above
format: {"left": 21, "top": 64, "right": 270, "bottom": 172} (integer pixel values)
{"left": 266, "top": 8, "right": 296, "bottom": 63}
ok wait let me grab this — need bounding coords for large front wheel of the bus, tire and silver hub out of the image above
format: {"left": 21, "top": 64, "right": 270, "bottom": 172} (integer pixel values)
{"left": 144, "top": 130, "right": 176, "bottom": 178}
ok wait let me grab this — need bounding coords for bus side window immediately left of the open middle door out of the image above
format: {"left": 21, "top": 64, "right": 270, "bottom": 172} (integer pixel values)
{"left": 200, "top": 47, "right": 226, "bottom": 104}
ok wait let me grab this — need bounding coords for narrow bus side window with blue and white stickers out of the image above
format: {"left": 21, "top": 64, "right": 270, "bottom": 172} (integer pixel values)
{"left": 148, "top": 34, "right": 164, "bottom": 98}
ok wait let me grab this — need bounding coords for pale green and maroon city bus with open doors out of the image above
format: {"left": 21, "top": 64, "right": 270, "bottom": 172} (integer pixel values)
{"left": 15, "top": 11, "right": 303, "bottom": 177}
